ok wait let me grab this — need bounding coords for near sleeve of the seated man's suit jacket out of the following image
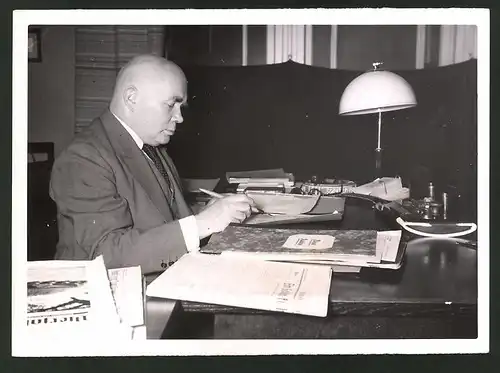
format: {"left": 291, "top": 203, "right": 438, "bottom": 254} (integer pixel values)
{"left": 50, "top": 144, "right": 187, "bottom": 273}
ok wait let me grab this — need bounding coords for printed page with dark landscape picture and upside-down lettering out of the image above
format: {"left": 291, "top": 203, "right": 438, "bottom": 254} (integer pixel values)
{"left": 26, "top": 256, "right": 126, "bottom": 339}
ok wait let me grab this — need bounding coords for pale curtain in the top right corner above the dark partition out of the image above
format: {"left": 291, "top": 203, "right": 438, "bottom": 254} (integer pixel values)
{"left": 439, "top": 25, "right": 477, "bottom": 66}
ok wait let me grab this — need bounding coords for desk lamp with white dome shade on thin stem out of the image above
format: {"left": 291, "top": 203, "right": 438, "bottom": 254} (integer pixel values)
{"left": 339, "top": 62, "right": 417, "bottom": 178}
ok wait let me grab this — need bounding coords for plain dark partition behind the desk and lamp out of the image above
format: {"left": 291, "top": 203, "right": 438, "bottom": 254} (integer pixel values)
{"left": 169, "top": 60, "right": 477, "bottom": 219}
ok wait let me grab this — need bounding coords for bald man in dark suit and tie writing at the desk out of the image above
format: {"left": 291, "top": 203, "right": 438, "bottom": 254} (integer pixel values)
{"left": 50, "top": 55, "right": 253, "bottom": 273}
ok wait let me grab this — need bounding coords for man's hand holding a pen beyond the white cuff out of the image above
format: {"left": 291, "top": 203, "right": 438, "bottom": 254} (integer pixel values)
{"left": 195, "top": 194, "right": 255, "bottom": 240}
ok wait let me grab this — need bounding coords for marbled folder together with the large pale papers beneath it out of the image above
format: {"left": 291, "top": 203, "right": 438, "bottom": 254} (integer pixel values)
{"left": 147, "top": 226, "right": 404, "bottom": 317}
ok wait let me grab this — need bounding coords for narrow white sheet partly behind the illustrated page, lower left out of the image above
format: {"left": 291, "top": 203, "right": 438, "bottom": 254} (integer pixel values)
{"left": 108, "top": 266, "right": 144, "bottom": 326}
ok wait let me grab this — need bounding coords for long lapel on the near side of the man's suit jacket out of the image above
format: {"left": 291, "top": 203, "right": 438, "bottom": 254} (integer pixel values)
{"left": 101, "top": 110, "right": 172, "bottom": 220}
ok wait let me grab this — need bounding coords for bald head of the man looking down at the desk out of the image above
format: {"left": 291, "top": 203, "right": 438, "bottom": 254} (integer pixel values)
{"left": 110, "top": 55, "right": 187, "bottom": 146}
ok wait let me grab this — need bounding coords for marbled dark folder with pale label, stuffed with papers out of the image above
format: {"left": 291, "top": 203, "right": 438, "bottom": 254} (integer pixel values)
{"left": 200, "top": 226, "right": 405, "bottom": 272}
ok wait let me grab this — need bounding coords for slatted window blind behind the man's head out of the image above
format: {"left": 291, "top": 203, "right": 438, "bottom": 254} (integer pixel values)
{"left": 75, "top": 25, "right": 165, "bottom": 132}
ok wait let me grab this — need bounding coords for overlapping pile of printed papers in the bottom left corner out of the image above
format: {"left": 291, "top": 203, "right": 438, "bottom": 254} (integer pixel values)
{"left": 26, "top": 256, "right": 145, "bottom": 342}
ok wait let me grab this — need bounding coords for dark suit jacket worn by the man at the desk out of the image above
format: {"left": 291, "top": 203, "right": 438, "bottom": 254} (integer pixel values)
{"left": 50, "top": 110, "right": 192, "bottom": 273}
